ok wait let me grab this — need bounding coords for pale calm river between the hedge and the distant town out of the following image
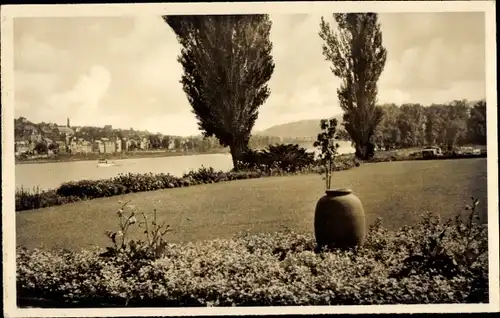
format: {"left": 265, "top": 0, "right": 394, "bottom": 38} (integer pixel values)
{"left": 15, "top": 142, "right": 354, "bottom": 190}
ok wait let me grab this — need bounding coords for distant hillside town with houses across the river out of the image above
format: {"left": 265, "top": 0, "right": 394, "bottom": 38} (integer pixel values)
{"left": 14, "top": 117, "right": 312, "bottom": 161}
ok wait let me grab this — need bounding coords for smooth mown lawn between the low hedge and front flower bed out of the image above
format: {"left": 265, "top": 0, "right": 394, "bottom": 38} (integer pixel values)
{"left": 16, "top": 158, "right": 487, "bottom": 249}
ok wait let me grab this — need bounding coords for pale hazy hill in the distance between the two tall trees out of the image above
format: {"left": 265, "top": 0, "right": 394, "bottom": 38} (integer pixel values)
{"left": 255, "top": 115, "right": 342, "bottom": 138}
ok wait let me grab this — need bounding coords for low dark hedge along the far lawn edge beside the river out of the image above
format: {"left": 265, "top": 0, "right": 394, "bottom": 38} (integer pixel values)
{"left": 16, "top": 156, "right": 359, "bottom": 211}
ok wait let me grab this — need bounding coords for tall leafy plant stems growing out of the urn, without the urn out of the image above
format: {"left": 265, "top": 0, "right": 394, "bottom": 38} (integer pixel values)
{"left": 314, "top": 118, "right": 339, "bottom": 190}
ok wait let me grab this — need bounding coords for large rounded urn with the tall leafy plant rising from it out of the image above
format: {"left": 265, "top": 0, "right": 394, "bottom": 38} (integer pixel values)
{"left": 314, "top": 119, "right": 366, "bottom": 248}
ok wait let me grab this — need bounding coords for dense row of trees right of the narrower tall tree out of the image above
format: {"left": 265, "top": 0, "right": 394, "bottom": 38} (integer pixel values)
{"left": 374, "top": 100, "right": 486, "bottom": 150}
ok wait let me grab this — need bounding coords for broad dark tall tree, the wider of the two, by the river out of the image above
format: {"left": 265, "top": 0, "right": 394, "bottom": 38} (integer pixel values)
{"left": 163, "top": 14, "right": 274, "bottom": 169}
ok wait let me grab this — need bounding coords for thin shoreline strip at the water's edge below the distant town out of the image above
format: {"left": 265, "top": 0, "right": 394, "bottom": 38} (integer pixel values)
{"left": 15, "top": 149, "right": 229, "bottom": 165}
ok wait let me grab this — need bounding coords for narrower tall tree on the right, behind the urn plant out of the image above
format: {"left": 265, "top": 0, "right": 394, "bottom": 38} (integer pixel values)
{"left": 319, "top": 13, "right": 387, "bottom": 159}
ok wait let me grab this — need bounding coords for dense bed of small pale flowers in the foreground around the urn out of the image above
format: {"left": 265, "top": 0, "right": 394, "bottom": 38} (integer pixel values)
{"left": 17, "top": 201, "right": 488, "bottom": 307}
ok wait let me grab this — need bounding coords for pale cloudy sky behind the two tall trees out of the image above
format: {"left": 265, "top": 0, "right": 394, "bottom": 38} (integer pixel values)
{"left": 14, "top": 12, "right": 486, "bottom": 136}
